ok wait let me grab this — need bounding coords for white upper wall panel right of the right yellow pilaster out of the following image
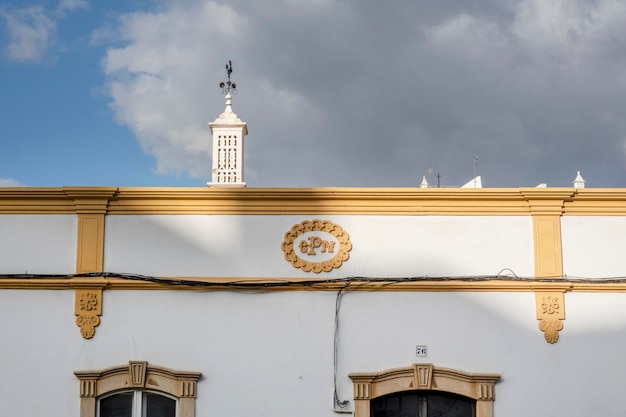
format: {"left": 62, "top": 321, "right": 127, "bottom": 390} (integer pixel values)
{"left": 561, "top": 216, "right": 626, "bottom": 278}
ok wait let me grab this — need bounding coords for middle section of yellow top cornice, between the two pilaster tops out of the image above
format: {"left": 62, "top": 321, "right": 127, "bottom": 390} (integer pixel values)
{"left": 109, "top": 188, "right": 529, "bottom": 215}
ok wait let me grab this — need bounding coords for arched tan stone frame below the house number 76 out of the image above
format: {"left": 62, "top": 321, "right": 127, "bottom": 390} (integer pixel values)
{"left": 348, "top": 363, "right": 500, "bottom": 417}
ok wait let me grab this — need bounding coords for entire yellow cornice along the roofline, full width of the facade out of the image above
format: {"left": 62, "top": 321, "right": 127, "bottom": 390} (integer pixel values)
{"left": 0, "top": 187, "right": 626, "bottom": 216}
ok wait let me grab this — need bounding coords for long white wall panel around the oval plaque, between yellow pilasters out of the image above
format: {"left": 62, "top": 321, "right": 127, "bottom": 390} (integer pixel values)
{"left": 104, "top": 215, "right": 534, "bottom": 278}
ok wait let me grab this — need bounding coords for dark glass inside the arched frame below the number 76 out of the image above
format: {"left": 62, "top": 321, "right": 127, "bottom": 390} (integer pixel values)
{"left": 370, "top": 392, "right": 474, "bottom": 417}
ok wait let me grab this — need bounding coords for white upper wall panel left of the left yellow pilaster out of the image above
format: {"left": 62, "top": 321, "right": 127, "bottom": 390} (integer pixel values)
{"left": 0, "top": 214, "right": 77, "bottom": 274}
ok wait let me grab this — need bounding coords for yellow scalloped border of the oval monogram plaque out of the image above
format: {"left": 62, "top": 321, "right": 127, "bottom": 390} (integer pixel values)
{"left": 280, "top": 220, "right": 352, "bottom": 274}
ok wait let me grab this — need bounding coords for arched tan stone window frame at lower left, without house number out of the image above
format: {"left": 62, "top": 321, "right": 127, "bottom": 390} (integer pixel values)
{"left": 74, "top": 361, "right": 202, "bottom": 417}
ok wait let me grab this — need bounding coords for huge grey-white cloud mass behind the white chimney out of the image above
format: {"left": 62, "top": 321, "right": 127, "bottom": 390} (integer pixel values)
{"left": 94, "top": 0, "right": 626, "bottom": 186}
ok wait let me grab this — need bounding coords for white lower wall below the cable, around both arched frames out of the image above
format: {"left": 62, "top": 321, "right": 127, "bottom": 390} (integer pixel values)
{"left": 0, "top": 290, "right": 626, "bottom": 417}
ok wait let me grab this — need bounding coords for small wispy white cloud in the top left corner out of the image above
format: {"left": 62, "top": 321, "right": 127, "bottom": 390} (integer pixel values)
{"left": 0, "top": 6, "right": 56, "bottom": 62}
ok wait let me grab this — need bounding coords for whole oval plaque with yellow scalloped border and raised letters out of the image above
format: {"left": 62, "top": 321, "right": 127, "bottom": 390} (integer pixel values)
{"left": 280, "top": 220, "right": 352, "bottom": 274}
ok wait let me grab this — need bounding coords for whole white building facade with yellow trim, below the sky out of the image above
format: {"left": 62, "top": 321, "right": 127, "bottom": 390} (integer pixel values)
{"left": 0, "top": 187, "right": 626, "bottom": 417}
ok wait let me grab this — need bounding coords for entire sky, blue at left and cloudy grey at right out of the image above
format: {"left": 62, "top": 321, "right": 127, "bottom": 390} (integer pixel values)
{"left": 0, "top": 0, "right": 626, "bottom": 187}
